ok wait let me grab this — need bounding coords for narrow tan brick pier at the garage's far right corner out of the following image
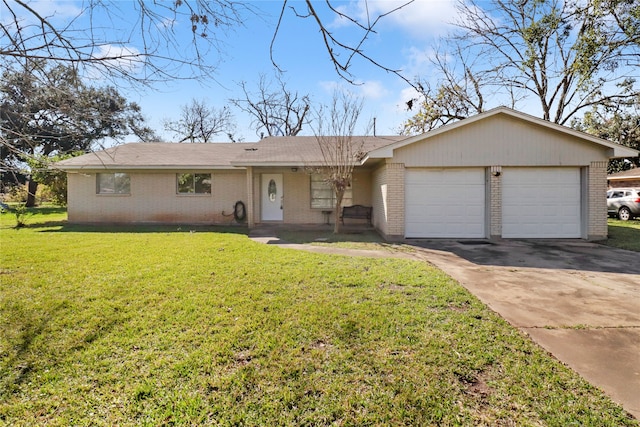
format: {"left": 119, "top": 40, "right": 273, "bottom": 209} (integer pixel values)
{"left": 586, "top": 161, "right": 608, "bottom": 240}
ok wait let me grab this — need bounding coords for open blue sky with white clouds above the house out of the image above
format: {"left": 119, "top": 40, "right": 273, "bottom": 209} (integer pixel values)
{"left": 0, "top": 0, "right": 464, "bottom": 141}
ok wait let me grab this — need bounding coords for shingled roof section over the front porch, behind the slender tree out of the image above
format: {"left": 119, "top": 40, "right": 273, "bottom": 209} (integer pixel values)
{"left": 231, "top": 136, "right": 407, "bottom": 166}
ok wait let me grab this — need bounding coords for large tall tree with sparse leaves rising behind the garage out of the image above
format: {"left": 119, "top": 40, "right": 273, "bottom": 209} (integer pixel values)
{"left": 405, "top": 0, "right": 640, "bottom": 132}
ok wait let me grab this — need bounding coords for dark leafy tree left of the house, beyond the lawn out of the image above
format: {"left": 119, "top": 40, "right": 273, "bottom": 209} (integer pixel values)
{"left": 0, "top": 61, "right": 152, "bottom": 206}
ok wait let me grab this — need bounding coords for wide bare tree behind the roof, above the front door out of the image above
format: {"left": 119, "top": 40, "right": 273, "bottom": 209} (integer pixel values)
{"left": 231, "top": 73, "right": 311, "bottom": 136}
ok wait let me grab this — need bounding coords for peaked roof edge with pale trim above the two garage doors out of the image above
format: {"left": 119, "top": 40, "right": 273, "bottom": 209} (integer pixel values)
{"left": 367, "top": 107, "right": 638, "bottom": 159}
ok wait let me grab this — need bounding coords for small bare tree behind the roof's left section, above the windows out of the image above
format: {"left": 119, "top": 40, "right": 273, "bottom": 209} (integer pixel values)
{"left": 164, "top": 99, "right": 235, "bottom": 143}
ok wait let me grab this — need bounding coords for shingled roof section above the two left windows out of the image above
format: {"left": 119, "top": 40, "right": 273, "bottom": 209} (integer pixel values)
{"left": 56, "top": 142, "right": 256, "bottom": 170}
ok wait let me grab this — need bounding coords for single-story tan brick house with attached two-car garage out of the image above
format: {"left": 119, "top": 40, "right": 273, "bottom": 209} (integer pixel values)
{"left": 58, "top": 107, "right": 638, "bottom": 240}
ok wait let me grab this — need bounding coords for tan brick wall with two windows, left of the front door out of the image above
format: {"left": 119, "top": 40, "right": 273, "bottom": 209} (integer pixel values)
{"left": 68, "top": 170, "right": 247, "bottom": 224}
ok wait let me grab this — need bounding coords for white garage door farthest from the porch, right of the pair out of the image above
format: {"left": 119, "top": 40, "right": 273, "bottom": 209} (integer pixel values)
{"left": 502, "top": 168, "right": 581, "bottom": 238}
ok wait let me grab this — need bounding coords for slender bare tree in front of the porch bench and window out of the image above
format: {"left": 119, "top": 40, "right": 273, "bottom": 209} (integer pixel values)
{"left": 314, "top": 91, "right": 365, "bottom": 234}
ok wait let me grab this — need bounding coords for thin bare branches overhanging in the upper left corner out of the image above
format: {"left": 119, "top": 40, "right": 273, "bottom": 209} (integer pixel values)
{"left": 0, "top": 0, "right": 254, "bottom": 85}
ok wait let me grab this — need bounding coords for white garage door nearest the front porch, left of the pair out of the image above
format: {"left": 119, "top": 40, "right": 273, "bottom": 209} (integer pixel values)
{"left": 405, "top": 168, "right": 485, "bottom": 238}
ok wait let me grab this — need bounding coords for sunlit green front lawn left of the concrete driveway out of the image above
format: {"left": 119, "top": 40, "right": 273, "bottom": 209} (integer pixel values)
{"left": 0, "top": 211, "right": 638, "bottom": 426}
